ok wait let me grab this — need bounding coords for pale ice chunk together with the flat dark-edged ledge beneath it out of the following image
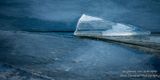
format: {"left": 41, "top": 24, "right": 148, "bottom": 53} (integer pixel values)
{"left": 74, "top": 15, "right": 160, "bottom": 50}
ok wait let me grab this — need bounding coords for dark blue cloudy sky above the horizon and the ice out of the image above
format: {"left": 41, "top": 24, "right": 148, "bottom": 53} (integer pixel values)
{"left": 0, "top": 0, "right": 160, "bottom": 32}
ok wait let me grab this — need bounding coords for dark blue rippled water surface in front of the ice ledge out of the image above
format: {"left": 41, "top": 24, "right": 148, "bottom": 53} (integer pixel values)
{"left": 0, "top": 31, "right": 160, "bottom": 80}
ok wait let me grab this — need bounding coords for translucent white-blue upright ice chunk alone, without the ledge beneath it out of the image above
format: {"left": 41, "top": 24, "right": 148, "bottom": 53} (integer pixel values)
{"left": 74, "top": 14, "right": 150, "bottom": 36}
